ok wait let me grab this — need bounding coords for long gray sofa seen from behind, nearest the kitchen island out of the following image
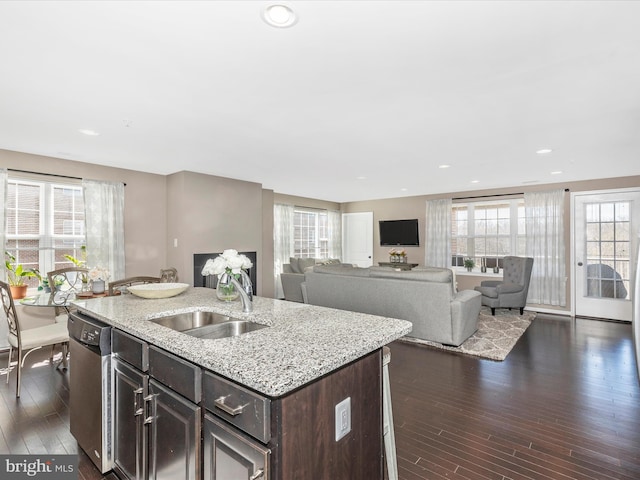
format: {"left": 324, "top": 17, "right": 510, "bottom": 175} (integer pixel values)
{"left": 301, "top": 266, "right": 481, "bottom": 346}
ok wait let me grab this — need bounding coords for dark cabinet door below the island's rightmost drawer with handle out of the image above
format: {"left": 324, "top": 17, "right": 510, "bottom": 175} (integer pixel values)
{"left": 204, "top": 414, "right": 271, "bottom": 480}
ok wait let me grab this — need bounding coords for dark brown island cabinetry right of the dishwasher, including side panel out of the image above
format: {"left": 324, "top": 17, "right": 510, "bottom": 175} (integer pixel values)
{"left": 112, "top": 329, "right": 383, "bottom": 480}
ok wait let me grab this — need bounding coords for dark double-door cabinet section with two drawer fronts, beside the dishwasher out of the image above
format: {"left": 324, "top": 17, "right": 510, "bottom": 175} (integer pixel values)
{"left": 112, "top": 330, "right": 202, "bottom": 480}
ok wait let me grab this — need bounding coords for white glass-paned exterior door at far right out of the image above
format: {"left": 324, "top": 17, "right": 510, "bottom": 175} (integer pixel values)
{"left": 573, "top": 190, "right": 640, "bottom": 322}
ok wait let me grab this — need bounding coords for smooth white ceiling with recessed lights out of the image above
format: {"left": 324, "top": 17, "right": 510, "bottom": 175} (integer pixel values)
{"left": 0, "top": 1, "right": 640, "bottom": 202}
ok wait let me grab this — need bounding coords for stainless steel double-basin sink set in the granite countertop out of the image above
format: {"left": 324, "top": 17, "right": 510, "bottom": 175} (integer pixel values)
{"left": 149, "top": 312, "right": 268, "bottom": 339}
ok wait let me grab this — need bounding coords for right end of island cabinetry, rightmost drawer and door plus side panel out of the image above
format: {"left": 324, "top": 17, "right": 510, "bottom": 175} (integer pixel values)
{"left": 203, "top": 350, "right": 383, "bottom": 480}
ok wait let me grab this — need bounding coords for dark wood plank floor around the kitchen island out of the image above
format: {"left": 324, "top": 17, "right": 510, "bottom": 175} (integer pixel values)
{"left": 0, "top": 315, "right": 640, "bottom": 480}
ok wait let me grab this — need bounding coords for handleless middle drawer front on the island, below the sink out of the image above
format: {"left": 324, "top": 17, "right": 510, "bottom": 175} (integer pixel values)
{"left": 149, "top": 345, "right": 202, "bottom": 403}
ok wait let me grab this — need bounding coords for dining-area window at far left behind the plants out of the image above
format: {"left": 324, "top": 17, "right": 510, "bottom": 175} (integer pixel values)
{"left": 7, "top": 179, "right": 85, "bottom": 287}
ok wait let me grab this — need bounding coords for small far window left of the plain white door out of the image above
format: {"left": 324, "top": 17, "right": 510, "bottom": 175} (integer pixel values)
{"left": 293, "top": 208, "right": 329, "bottom": 258}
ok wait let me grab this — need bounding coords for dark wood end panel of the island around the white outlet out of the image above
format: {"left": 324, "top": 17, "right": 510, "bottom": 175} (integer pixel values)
{"left": 272, "top": 349, "right": 383, "bottom": 480}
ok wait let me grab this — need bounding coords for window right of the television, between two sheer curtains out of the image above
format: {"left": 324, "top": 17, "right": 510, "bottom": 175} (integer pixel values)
{"left": 451, "top": 199, "right": 526, "bottom": 266}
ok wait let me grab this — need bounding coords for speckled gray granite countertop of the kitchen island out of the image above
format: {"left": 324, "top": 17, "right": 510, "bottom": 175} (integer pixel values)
{"left": 73, "top": 287, "right": 411, "bottom": 397}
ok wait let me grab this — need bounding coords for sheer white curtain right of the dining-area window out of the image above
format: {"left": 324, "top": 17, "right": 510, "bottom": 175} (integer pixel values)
{"left": 82, "top": 180, "right": 125, "bottom": 280}
